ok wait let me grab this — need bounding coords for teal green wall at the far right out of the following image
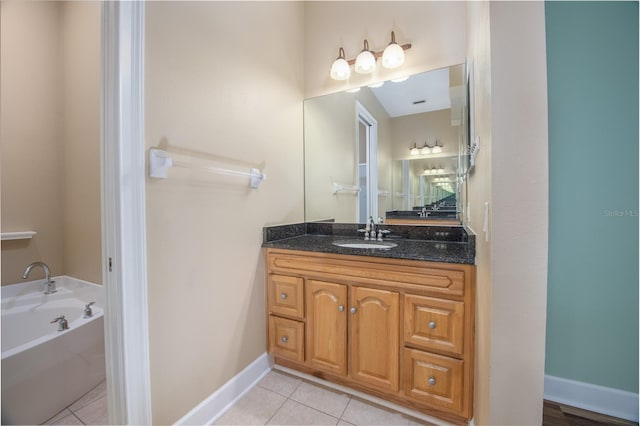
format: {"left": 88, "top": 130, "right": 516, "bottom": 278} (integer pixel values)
{"left": 545, "top": 2, "right": 638, "bottom": 393}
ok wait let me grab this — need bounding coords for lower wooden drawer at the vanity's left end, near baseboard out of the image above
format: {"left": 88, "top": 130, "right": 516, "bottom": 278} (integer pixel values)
{"left": 269, "top": 315, "right": 304, "bottom": 362}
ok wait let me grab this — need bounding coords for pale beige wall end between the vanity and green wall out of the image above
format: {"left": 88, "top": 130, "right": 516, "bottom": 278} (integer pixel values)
{"left": 467, "top": 2, "right": 548, "bottom": 425}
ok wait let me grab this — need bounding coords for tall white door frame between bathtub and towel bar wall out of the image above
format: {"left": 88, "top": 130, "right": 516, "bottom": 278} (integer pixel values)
{"left": 100, "top": 1, "right": 152, "bottom": 424}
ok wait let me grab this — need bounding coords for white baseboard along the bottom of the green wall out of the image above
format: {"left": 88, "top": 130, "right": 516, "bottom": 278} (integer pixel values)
{"left": 544, "top": 375, "right": 638, "bottom": 422}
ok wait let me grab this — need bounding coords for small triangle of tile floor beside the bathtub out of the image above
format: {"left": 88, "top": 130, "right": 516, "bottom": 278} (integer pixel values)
{"left": 44, "top": 380, "right": 108, "bottom": 425}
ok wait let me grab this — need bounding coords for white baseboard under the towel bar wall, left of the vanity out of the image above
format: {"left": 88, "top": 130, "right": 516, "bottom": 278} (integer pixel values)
{"left": 175, "top": 352, "right": 271, "bottom": 425}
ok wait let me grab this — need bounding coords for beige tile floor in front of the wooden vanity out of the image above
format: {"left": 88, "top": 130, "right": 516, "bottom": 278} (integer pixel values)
{"left": 216, "top": 370, "right": 428, "bottom": 426}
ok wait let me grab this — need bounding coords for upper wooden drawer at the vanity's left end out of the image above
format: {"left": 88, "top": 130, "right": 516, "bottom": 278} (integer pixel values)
{"left": 267, "top": 275, "right": 304, "bottom": 319}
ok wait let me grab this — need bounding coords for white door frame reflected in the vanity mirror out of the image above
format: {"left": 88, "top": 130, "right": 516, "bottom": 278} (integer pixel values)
{"left": 355, "top": 101, "right": 378, "bottom": 221}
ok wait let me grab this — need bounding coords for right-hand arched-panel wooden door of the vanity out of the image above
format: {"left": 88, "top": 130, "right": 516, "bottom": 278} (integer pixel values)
{"left": 349, "top": 286, "right": 400, "bottom": 392}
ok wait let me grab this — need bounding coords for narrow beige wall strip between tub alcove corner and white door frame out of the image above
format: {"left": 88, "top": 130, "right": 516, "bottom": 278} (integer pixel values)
{"left": 62, "top": 1, "right": 102, "bottom": 283}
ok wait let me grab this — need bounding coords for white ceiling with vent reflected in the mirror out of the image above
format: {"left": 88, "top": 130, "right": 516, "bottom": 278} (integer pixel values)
{"left": 371, "top": 67, "right": 451, "bottom": 117}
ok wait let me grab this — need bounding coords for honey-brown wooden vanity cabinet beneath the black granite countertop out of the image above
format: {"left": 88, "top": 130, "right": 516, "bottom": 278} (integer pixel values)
{"left": 265, "top": 249, "right": 475, "bottom": 423}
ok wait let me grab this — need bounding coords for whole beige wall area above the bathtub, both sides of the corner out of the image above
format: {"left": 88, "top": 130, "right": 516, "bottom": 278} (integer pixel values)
{"left": 0, "top": 1, "right": 102, "bottom": 284}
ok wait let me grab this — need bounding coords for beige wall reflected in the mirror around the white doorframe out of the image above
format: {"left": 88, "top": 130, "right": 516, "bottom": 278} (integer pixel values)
{"left": 304, "top": 88, "right": 392, "bottom": 223}
